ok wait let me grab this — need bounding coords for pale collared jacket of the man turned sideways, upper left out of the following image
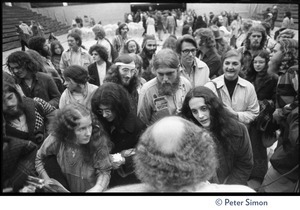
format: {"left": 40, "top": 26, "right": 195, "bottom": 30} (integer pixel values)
{"left": 59, "top": 47, "right": 93, "bottom": 73}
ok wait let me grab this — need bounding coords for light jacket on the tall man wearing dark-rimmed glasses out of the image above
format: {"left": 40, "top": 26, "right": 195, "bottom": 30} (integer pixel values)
{"left": 179, "top": 57, "right": 210, "bottom": 87}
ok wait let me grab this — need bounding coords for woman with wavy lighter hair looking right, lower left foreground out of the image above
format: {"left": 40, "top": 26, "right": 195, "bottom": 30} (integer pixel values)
{"left": 35, "top": 104, "right": 111, "bottom": 192}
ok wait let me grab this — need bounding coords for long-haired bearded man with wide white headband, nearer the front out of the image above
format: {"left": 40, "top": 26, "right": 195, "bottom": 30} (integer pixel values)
{"left": 104, "top": 54, "right": 140, "bottom": 113}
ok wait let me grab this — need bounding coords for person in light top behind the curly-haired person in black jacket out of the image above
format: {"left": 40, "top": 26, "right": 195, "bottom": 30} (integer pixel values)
{"left": 92, "top": 24, "right": 113, "bottom": 62}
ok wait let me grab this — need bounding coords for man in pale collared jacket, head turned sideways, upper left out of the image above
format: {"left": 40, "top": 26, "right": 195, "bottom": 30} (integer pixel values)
{"left": 59, "top": 33, "right": 93, "bottom": 74}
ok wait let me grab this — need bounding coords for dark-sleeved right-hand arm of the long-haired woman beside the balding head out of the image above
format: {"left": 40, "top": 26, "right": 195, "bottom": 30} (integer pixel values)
{"left": 224, "top": 123, "right": 254, "bottom": 185}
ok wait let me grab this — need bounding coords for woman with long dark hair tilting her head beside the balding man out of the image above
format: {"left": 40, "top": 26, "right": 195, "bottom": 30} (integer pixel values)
{"left": 182, "top": 86, "right": 253, "bottom": 185}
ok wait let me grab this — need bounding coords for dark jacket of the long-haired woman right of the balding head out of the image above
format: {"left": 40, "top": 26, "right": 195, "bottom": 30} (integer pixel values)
{"left": 212, "top": 122, "right": 253, "bottom": 185}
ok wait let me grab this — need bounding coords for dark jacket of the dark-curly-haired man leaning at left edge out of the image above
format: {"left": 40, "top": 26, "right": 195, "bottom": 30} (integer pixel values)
{"left": 19, "top": 72, "right": 61, "bottom": 108}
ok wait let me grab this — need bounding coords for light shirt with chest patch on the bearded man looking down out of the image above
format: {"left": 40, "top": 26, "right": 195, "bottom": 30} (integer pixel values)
{"left": 137, "top": 76, "right": 192, "bottom": 125}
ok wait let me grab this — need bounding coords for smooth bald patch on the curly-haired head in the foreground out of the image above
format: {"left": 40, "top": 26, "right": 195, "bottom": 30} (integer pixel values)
{"left": 152, "top": 117, "right": 184, "bottom": 153}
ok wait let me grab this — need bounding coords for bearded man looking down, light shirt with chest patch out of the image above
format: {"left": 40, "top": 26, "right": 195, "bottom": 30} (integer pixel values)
{"left": 137, "top": 48, "right": 192, "bottom": 125}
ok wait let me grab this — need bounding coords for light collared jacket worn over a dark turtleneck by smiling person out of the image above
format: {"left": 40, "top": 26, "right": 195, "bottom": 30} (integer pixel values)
{"left": 205, "top": 75, "right": 259, "bottom": 124}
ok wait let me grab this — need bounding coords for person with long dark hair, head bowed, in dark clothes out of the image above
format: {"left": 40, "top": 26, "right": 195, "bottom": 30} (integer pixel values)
{"left": 91, "top": 82, "right": 145, "bottom": 187}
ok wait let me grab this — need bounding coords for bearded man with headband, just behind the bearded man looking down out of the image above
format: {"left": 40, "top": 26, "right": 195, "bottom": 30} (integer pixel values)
{"left": 140, "top": 34, "right": 157, "bottom": 81}
